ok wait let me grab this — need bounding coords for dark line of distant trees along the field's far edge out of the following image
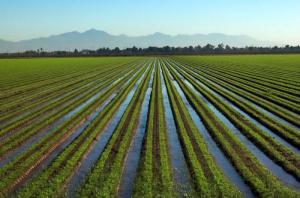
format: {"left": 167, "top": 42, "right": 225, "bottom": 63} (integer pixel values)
{"left": 0, "top": 44, "right": 300, "bottom": 58}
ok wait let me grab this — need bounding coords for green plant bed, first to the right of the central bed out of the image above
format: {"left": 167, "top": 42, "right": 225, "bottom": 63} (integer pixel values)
{"left": 162, "top": 61, "right": 242, "bottom": 197}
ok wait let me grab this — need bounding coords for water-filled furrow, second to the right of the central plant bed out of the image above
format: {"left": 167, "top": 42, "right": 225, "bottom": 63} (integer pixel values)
{"left": 164, "top": 67, "right": 254, "bottom": 197}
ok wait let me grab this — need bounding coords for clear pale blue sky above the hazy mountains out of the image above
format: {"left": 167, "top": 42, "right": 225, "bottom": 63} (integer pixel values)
{"left": 0, "top": 0, "right": 300, "bottom": 44}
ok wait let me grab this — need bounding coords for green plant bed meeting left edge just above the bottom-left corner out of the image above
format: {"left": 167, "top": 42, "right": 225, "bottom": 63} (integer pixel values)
{"left": 0, "top": 61, "right": 148, "bottom": 194}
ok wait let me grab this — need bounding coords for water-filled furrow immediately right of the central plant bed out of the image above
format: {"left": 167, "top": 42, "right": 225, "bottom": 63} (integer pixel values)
{"left": 160, "top": 67, "right": 196, "bottom": 197}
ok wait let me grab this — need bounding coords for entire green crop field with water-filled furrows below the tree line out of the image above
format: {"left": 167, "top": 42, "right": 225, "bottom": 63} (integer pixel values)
{"left": 0, "top": 55, "right": 300, "bottom": 198}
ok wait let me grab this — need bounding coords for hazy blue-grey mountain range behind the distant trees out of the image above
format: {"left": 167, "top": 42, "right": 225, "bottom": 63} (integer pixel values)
{"left": 0, "top": 29, "right": 270, "bottom": 52}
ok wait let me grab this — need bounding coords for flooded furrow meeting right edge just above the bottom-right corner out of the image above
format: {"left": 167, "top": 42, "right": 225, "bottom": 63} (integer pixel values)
{"left": 169, "top": 66, "right": 300, "bottom": 190}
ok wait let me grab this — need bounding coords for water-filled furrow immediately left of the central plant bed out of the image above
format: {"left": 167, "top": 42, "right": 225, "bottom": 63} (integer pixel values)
{"left": 118, "top": 66, "right": 155, "bottom": 197}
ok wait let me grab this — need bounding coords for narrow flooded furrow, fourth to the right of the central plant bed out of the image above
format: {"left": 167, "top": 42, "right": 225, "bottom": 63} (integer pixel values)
{"left": 175, "top": 65, "right": 300, "bottom": 155}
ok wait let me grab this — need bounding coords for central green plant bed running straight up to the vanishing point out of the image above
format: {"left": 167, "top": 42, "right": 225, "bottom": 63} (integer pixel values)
{"left": 133, "top": 64, "right": 174, "bottom": 197}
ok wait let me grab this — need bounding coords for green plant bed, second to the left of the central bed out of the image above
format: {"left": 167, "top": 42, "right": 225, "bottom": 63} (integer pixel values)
{"left": 17, "top": 61, "right": 150, "bottom": 197}
